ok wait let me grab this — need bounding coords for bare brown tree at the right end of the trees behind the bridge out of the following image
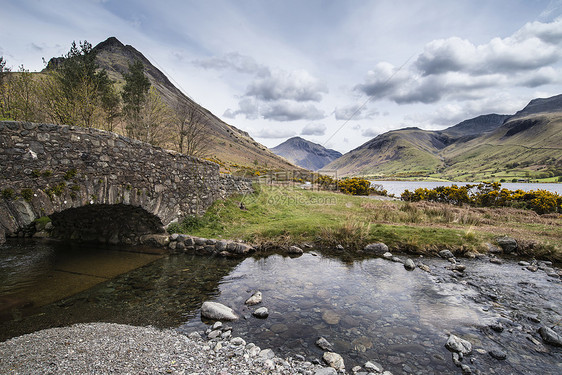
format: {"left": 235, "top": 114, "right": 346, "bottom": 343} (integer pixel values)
{"left": 175, "top": 99, "right": 210, "bottom": 157}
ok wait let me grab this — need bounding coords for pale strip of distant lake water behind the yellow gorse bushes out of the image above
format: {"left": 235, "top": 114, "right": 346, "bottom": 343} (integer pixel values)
{"left": 371, "top": 181, "right": 562, "bottom": 197}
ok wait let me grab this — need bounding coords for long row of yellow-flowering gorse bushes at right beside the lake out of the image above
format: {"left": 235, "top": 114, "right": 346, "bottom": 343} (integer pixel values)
{"left": 401, "top": 182, "right": 562, "bottom": 214}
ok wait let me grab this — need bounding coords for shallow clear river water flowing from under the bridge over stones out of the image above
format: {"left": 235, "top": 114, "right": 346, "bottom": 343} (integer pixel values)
{"left": 0, "top": 240, "right": 562, "bottom": 375}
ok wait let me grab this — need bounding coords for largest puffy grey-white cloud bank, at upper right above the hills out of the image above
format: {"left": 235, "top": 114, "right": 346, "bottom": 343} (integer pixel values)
{"left": 352, "top": 18, "right": 562, "bottom": 106}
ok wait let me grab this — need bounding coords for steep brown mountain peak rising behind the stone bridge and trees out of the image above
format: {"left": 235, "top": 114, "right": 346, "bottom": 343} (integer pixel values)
{"left": 47, "top": 37, "right": 295, "bottom": 173}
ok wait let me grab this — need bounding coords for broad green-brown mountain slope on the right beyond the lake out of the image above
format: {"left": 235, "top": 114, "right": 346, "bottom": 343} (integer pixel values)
{"left": 325, "top": 95, "right": 562, "bottom": 181}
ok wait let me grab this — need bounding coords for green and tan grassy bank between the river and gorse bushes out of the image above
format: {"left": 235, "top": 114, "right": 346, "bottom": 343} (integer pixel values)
{"left": 169, "top": 186, "right": 562, "bottom": 261}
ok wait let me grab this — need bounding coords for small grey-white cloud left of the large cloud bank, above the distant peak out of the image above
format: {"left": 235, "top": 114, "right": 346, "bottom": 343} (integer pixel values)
{"left": 246, "top": 70, "right": 328, "bottom": 102}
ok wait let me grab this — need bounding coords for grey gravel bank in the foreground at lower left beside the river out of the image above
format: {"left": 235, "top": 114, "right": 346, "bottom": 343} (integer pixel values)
{"left": 0, "top": 323, "right": 335, "bottom": 375}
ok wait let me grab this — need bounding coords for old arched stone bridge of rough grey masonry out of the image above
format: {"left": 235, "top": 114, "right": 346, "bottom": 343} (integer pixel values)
{"left": 0, "top": 121, "right": 252, "bottom": 244}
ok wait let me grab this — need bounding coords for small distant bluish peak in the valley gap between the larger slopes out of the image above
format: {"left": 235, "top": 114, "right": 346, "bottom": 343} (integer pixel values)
{"left": 271, "top": 137, "right": 342, "bottom": 171}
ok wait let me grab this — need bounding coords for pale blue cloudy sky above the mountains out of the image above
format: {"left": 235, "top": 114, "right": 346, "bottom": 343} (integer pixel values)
{"left": 0, "top": 0, "right": 562, "bottom": 153}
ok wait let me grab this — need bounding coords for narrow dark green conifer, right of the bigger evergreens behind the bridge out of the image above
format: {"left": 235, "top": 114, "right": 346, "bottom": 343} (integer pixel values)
{"left": 121, "top": 60, "right": 151, "bottom": 137}
